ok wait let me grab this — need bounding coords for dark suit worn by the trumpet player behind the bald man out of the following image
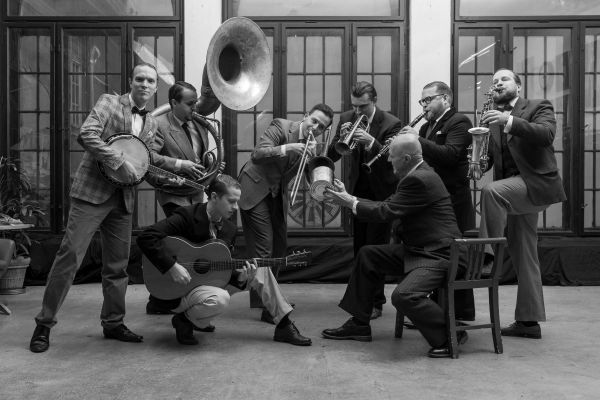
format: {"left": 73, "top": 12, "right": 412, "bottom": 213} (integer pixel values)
{"left": 327, "top": 108, "right": 402, "bottom": 308}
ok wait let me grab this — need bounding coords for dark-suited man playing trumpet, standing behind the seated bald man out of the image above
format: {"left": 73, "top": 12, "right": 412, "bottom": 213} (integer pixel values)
{"left": 327, "top": 82, "right": 402, "bottom": 318}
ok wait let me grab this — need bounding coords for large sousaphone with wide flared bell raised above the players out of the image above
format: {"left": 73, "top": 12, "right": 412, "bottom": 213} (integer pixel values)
{"left": 151, "top": 17, "right": 272, "bottom": 194}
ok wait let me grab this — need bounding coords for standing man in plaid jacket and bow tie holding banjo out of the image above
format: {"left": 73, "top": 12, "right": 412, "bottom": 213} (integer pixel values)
{"left": 29, "top": 63, "right": 158, "bottom": 353}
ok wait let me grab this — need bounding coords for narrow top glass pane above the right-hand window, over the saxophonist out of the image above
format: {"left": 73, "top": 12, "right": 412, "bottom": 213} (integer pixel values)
{"left": 458, "top": 0, "right": 600, "bottom": 17}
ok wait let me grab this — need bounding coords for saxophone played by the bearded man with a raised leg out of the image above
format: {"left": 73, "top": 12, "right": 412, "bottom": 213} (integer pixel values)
{"left": 467, "top": 86, "right": 495, "bottom": 181}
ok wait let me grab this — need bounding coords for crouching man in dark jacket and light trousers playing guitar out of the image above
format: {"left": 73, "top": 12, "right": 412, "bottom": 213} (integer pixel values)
{"left": 137, "top": 175, "right": 311, "bottom": 346}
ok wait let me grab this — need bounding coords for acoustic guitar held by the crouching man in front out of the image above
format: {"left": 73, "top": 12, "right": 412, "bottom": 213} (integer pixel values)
{"left": 142, "top": 236, "right": 311, "bottom": 300}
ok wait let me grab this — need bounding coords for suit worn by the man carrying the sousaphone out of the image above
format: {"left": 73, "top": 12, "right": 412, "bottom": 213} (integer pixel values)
{"left": 149, "top": 111, "right": 209, "bottom": 216}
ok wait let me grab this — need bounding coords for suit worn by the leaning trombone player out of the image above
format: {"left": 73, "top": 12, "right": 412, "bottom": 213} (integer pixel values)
{"left": 238, "top": 118, "right": 300, "bottom": 257}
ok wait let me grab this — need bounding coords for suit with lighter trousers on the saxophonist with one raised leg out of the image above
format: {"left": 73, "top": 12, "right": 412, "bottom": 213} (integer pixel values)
{"left": 479, "top": 98, "right": 566, "bottom": 321}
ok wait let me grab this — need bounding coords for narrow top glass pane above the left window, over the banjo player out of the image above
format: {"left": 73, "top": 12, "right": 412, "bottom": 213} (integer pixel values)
{"left": 8, "top": 0, "right": 175, "bottom": 17}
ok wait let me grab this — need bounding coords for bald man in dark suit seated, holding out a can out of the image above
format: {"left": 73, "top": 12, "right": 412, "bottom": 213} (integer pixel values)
{"left": 322, "top": 135, "right": 467, "bottom": 358}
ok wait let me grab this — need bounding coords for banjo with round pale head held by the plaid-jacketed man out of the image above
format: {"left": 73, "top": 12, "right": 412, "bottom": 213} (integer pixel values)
{"left": 97, "top": 133, "right": 205, "bottom": 190}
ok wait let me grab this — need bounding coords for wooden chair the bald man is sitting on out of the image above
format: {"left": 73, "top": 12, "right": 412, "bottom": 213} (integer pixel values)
{"left": 394, "top": 238, "right": 506, "bottom": 358}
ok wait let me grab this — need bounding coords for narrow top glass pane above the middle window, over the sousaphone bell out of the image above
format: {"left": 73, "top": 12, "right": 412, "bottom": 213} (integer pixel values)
{"left": 232, "top": 0, "right": 401, "bottom": 17}
